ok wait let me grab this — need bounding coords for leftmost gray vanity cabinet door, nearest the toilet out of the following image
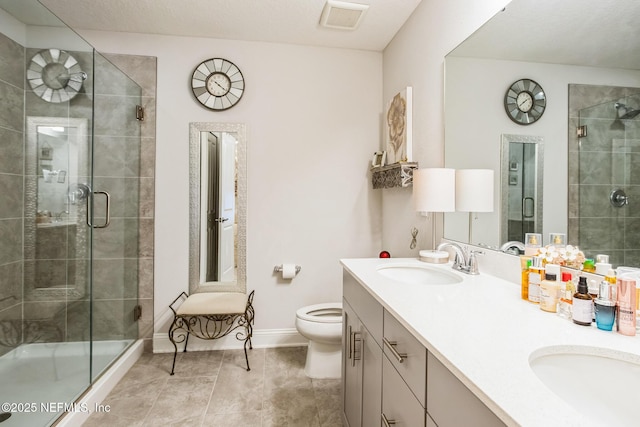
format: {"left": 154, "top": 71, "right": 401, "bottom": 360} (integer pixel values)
{"left": 342, "top": 299, "right": 362, "bottom": 427}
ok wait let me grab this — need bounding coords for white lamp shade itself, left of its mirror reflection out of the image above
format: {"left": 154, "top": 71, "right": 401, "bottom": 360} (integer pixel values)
{"left": 413, "top": 168, "right": 456, "bottom": 212}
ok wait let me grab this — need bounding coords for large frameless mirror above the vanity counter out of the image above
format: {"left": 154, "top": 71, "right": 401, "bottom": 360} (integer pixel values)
{"left": 444, "top": 0, "right": 640, "bottom": 265}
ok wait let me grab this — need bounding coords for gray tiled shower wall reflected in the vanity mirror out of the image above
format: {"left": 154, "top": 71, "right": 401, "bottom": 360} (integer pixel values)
{"left": 568, "top": 85, "right": 640, "bottom": 266}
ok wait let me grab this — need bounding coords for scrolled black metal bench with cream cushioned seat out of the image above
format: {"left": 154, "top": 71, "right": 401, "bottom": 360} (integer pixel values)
{"left": 169, "top": 291, "right": 255, "bottom": 375}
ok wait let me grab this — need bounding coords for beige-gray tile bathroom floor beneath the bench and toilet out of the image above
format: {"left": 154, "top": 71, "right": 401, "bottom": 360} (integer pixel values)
{"left": 83, "top": 347, "right": 342, "bottom": 427}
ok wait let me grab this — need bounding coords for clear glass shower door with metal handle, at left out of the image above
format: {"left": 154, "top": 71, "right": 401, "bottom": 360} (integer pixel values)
{"left": 89, "top": 52, "right": 142, "bottom": 380}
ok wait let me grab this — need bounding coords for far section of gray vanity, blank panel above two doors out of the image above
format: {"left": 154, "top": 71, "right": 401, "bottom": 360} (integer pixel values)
{"left": 342, "top": 272, "right": 383, "bottom": 427}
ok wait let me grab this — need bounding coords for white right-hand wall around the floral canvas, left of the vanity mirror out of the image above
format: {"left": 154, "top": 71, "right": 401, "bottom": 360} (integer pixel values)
{"left": 382, "top": 0, "right": 508, "bottom": 256}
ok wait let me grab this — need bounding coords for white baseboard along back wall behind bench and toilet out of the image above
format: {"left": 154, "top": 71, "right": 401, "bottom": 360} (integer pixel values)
{"left": 153, "top": 328, "right": 309, "bottom": 353}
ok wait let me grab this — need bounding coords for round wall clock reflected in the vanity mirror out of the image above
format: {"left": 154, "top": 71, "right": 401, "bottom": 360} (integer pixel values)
{"left": 504, "top": 79, "right": 547, "bottom": 125}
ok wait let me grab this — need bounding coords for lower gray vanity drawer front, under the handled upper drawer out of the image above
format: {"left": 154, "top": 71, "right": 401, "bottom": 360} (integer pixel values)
{"left": 380, "top": 356, "right": 426, "bottom": 427}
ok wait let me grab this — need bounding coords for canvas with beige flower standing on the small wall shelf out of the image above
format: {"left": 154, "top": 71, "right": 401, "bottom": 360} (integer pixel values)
{"left": 385, "top": 86, "right": 412, "bottom": 164}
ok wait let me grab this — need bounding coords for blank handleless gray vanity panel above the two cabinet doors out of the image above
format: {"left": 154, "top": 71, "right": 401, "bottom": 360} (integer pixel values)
{"left": 342, "top": 270, "right": 382, "bottom": 347}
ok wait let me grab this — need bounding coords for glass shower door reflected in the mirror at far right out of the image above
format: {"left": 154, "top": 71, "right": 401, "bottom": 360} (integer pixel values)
{"left": 576, "top": 89, "right": 640, "bottom": 265}
